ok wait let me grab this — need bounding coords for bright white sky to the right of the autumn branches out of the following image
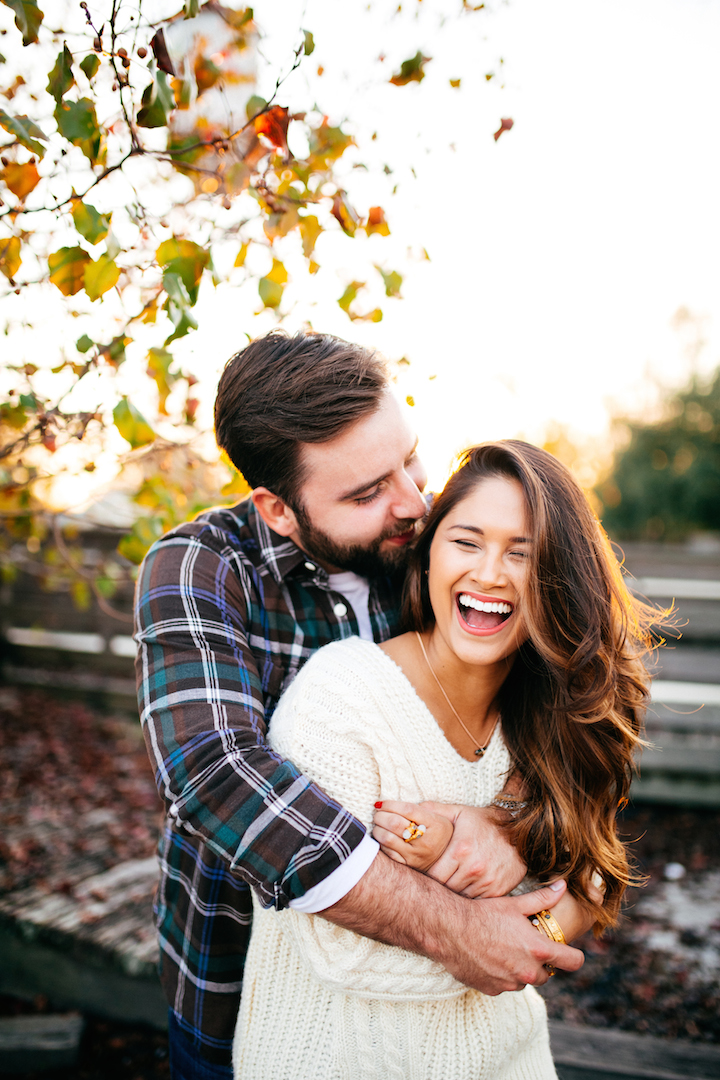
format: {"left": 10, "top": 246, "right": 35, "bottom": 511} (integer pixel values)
{"left": 177, "top": 0, "right": 720, "bottom": 478}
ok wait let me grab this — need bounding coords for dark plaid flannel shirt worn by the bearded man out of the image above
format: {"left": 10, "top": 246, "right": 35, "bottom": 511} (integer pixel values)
{"left": 135, "top": 501, "right": 402, "bottom": 1064}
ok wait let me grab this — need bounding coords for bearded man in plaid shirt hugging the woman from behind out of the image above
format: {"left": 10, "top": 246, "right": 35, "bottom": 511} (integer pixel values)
{"left": 136, "top": 332, "right": 582, "bottom": 1080}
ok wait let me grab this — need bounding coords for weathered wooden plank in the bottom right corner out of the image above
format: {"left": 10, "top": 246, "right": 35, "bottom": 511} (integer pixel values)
{"left": 549, "top": 1021, "right": 720, "bottom": 1080}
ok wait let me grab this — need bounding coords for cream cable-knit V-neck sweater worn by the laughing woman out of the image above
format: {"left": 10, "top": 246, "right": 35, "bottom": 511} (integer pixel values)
{"left": 233, "top": 637, "right": 556, "bottom": 1080}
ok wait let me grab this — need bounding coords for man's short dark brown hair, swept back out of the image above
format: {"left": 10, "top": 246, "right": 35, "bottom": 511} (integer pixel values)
{"left": 215, "top": 330, "right": 388, "bottom": 509}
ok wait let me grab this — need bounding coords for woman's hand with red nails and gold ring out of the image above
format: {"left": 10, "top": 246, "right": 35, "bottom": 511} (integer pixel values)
{"left": 372, "top": 799, "right": 452, "bottom": 872}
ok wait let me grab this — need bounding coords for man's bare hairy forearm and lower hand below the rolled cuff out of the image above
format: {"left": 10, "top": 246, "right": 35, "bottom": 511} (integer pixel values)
{"left": 322, "top": 851, "right": 584, "bottom": 995}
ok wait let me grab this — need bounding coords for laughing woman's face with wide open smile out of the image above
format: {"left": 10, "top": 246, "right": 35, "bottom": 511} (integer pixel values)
{"left": 429, "top": 476, "right": 531, "bottom": 664}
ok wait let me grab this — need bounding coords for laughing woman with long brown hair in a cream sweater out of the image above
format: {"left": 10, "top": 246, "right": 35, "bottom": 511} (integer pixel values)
{"left": 234, "top": 442, "right": 654, "bottom": 1080}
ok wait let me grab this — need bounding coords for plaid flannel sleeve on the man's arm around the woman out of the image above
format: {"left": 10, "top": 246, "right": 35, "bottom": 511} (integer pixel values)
{"left": 136, "top": 522, "right": 365, "bottom": 907}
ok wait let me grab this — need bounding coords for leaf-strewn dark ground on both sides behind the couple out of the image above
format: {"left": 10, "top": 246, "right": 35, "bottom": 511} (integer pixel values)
{"left": 0, "top": 688, "right": 720, "bottom": 1080}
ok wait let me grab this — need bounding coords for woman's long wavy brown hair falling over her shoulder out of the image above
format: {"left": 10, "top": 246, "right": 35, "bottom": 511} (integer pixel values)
{"left": 404, "top": 440, "right": 667, "bottom": 932}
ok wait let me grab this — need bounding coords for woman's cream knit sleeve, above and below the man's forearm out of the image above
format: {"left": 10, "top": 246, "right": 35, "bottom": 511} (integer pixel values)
{"left": 264, "top": 643, "right": 466, "bottom": 1000}
